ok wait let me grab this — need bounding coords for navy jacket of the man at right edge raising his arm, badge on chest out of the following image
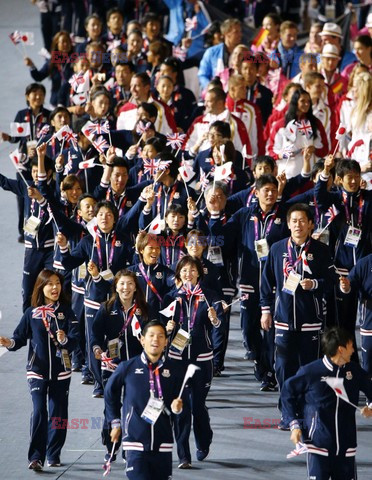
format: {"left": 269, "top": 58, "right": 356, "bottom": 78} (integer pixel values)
{"left": 315, "top": 174, "right": 372, "bottom": 274}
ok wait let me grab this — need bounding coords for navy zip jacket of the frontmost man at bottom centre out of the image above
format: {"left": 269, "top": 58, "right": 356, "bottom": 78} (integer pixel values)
{"left": 105, "top": 352, "right": 184, "bottom": 453}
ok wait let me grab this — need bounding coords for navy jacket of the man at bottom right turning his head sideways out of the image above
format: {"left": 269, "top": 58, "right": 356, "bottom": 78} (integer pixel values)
{"left": 280, "top": 356, "right": 372, "bottom": 457}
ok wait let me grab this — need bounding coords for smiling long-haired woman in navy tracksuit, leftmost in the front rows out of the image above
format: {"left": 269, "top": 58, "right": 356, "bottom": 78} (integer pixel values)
{"left": 0, "top": 270, "right": 78, "bottom": 471}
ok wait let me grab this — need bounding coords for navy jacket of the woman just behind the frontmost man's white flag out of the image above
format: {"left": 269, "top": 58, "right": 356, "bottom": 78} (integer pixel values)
{"left": 162, "top": 287, "right": 225, "bottom": 363}
